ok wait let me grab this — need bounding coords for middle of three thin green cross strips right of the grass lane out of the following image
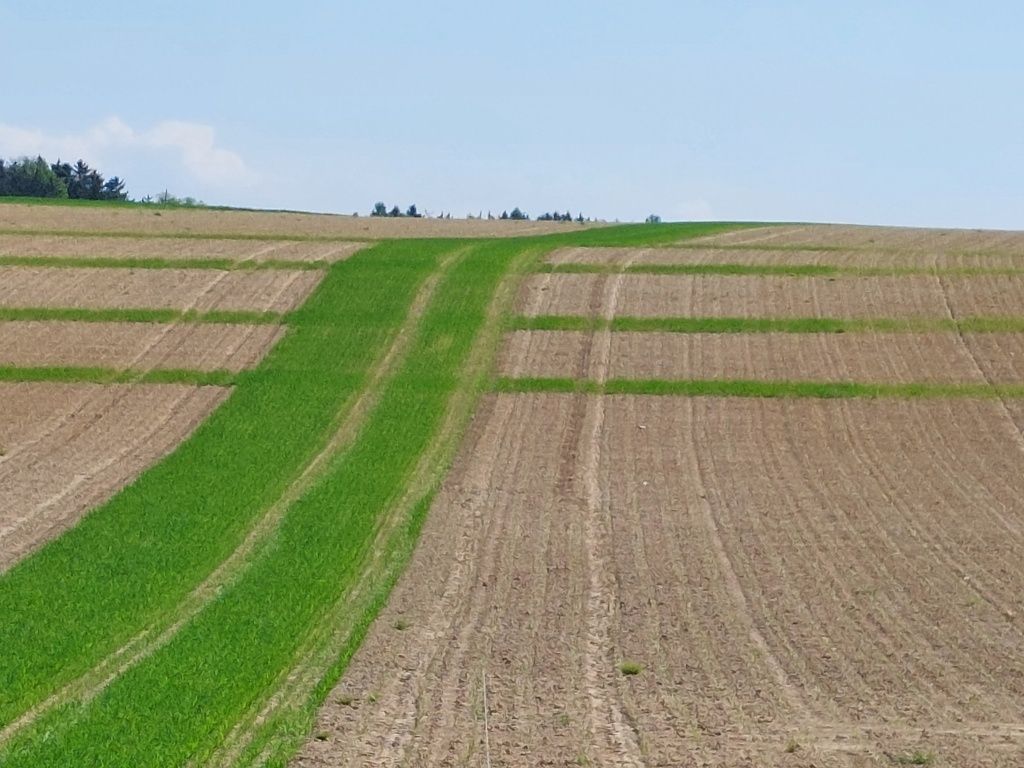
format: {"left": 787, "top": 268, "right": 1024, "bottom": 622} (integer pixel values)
{"left": 508, "top": 314, "right": 1024, "bottom": 334}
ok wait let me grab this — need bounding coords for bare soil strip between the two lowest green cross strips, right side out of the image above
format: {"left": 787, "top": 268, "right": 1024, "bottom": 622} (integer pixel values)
{"left": 499, "top": 331, "right": 1024, "bottom": 384}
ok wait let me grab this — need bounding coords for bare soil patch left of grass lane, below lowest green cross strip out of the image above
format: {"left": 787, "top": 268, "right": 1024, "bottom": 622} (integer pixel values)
{"left": 0, "top": 383, "right": 228, "bottom": 570}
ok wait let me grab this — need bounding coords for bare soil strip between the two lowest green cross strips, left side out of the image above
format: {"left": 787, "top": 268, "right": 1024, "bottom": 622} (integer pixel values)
{"left": 0, "top": 322, "right": 285, "bottom": 372}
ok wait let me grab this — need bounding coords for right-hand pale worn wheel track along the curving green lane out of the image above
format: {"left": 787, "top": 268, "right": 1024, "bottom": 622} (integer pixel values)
{"left": 209, "top": 243, "right": 540, "bottom": 768}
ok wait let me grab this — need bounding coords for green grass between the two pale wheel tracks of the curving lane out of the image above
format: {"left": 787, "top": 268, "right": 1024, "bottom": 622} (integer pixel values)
{"left": 4, "top": 244, "right": 536, "bottom": 768}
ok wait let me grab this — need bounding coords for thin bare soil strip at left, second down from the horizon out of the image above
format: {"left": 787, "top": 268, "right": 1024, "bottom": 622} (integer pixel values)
{"left": 0, "top": 234, "right": 367, "bottom": 261}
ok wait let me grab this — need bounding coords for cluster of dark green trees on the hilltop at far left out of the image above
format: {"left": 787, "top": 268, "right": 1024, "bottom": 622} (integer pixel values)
{"left": 0, "top": 157, "right": 128, "bottom": 200}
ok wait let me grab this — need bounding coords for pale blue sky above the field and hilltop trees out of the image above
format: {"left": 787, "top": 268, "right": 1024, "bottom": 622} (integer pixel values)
{"left": 0, "top": 0, "right": 1024, "bottom": 228}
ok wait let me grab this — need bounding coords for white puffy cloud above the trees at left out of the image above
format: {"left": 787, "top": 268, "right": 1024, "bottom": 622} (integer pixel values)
{"left": 0, "top": 117, "right": 256, "bottom": 187}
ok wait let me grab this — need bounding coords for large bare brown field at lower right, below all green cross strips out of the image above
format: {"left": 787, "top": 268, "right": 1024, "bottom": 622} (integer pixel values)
{"left": 295, "top": 394, "right": 1024, "bottom": 768}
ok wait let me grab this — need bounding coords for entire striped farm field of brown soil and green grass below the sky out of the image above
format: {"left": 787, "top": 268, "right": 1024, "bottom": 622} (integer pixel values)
{"left": 0, "top": 205, "right": 1024, "bottom": 768}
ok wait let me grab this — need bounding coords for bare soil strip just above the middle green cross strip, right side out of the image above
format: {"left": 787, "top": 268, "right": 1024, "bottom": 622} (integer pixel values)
{"left": 518, "top": 273, "right": 958, "bottom": 318}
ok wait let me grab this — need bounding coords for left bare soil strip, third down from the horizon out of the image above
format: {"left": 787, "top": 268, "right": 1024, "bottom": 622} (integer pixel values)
{"left": 0, "top": 264, "right": 323, "bottom": 312}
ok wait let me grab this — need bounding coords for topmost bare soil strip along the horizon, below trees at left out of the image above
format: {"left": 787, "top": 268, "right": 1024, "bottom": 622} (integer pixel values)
{"left": 0, "top": 203, "right": 585, "bottom": 240}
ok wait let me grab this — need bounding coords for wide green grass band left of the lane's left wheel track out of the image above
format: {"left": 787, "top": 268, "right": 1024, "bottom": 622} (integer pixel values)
{"left": 0, "top": 242, "right": 450, "bottom": 729}
